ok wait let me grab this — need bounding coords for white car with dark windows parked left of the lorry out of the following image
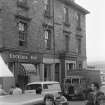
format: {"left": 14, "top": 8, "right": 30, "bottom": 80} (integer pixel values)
{"left": 24, "top": 81, "right": 61, "bottom": 96}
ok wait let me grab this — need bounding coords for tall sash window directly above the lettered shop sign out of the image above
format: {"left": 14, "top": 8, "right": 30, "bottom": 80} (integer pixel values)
{"left": 18, "top": 21, "right": 28, "bottom": 46}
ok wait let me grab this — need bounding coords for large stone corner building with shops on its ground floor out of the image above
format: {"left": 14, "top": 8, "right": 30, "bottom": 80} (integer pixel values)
{"left": 0, "top": 0, "right": 89, "bottom": 88}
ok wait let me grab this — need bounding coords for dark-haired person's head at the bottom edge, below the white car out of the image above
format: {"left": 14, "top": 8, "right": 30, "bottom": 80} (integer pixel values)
{"left": 44, "top": 94, "right": 55, "bottom": 105}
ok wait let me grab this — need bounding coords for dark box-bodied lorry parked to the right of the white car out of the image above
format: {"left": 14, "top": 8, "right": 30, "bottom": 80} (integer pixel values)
{"left": 63, "top": 70, "right": 101, "bottom": 100}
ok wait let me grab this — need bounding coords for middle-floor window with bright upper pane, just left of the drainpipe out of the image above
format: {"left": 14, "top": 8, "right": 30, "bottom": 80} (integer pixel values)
{"left": 44, "top": 30, "right": 51, "bottom": 49}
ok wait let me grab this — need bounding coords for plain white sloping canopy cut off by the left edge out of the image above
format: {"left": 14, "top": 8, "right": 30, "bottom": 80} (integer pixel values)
{"left": 0, "top": 56, "right": 13, "bottom": 77}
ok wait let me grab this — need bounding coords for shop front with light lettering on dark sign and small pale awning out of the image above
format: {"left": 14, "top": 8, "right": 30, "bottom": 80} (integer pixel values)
{"left": 2, "top": 52, "right": 42, "bottom": 89}
